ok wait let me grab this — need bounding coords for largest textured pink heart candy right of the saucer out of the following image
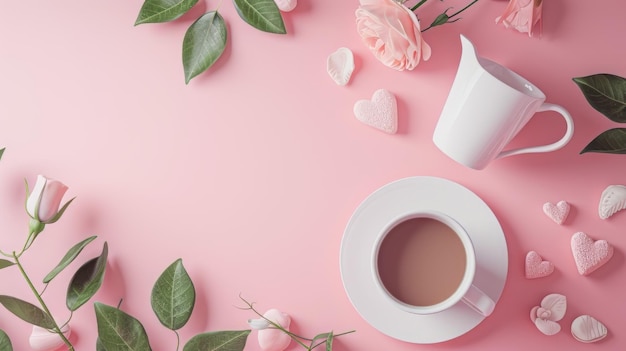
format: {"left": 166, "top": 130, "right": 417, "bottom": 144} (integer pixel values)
{"left": 572, "top": 232, "right": 613, "bottom": 275}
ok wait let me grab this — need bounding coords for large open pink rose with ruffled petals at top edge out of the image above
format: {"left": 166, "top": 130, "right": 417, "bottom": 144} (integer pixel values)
{"left": 356, "top": 0, "right": 430, "bottom": 71}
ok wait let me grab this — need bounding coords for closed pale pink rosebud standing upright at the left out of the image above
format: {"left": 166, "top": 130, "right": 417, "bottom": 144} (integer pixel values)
{"left": 26, "top": 175, "right": 67, "bottom": 223}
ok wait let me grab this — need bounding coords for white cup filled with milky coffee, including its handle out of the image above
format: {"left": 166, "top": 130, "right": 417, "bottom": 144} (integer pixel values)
{"left": 372, "top": 211, "right": 495, "bottom": 316}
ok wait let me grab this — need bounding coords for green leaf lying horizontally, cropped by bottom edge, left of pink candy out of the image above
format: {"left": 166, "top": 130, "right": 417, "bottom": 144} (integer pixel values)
{"left": 183, "top": 330, "right": 250, "bottom": 351}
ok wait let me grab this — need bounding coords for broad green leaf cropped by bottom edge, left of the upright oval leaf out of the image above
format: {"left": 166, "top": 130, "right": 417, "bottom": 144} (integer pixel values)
{"left": 94, "top": 302, "right": 152, "bottom": 351}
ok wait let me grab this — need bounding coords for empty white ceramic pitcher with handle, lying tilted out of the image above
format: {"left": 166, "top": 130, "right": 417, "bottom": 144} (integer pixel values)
{"left": 433, "top": 35, "right": 574, "bottom": 169}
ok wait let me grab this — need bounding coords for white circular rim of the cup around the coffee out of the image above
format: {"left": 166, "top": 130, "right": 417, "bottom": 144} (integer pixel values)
{"left": 370, "top": 211, "right": 476, "bottom": 315}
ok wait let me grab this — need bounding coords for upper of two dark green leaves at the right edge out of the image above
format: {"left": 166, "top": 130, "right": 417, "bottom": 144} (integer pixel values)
{"left": 574, "top": 74, "right": 626, "bottom": 123}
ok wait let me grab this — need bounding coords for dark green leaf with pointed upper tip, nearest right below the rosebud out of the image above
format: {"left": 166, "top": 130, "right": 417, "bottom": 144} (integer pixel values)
{"left": 65, "top": 242, "right": 109, "bottom": 311}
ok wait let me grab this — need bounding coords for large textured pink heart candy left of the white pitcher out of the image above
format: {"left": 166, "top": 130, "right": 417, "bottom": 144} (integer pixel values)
{"left": 354, "top": 89, "right": 398, "bottom": 134}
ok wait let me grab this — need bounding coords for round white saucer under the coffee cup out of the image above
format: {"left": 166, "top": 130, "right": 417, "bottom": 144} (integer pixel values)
{"left": 340, "top": 176, "right": 508, "bottom": 344}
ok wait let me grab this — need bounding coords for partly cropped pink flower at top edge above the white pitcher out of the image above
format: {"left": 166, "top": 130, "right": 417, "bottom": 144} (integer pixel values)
{"left": 496, "top": 0, "right": 543, "bottom": 37}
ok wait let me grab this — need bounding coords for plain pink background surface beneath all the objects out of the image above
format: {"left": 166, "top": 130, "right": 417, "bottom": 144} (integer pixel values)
{"left": 0, "top": 0, "right": 626, "bottom": 351}
